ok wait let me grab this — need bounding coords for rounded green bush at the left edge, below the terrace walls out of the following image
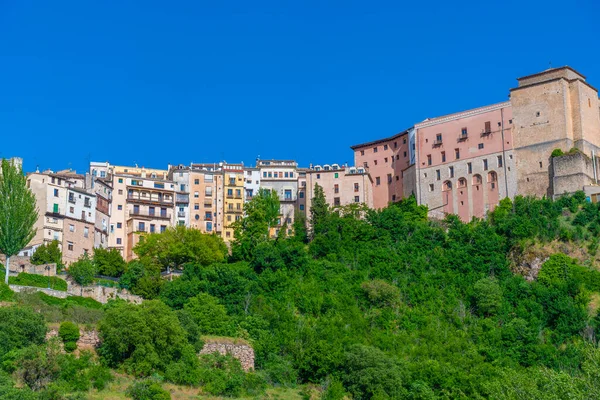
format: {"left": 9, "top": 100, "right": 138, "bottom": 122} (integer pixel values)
{"left": 0, "top": 306, "right": 46, "bottom": 357}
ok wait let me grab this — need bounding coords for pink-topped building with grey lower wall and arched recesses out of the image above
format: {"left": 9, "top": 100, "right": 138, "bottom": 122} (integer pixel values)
{"left": 412, "top": 102, "right": 516, "bottom": 221}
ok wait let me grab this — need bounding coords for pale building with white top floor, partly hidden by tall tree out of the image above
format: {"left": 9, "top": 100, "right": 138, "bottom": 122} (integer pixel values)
{"left": 256, "top": 160, "right": 298, "bottom": 235}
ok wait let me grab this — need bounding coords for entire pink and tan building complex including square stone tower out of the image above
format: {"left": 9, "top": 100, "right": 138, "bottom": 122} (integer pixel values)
{"left": 352, "top": 67, "right": 600, "bottom": 221}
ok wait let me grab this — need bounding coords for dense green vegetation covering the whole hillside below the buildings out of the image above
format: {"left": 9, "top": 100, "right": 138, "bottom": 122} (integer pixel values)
{"left": 0, "top": 190, "right": 600, "bottom": 399}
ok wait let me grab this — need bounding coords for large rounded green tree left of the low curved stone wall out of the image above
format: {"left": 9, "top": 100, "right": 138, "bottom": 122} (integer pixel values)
{"left": 98, "top": 300, "right": 197, "bottom": 376}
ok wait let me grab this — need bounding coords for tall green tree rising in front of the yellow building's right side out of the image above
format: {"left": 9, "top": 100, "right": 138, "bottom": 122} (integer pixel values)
{"left": 232, "top": 189, "right": 279, "bottom": 260}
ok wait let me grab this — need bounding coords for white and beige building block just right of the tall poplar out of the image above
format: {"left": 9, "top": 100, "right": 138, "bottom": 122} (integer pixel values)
{"left": 25, "top": 171, "right": 96, "bottom": 265}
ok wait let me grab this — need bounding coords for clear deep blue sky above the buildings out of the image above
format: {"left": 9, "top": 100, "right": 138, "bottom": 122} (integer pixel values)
{"left": 0, "top": 0, "right": 600, "bottom": 172}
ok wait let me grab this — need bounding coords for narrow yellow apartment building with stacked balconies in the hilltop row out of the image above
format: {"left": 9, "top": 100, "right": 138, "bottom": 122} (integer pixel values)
{"left": 222, "top": 164, "right": 245, "bottom": 242}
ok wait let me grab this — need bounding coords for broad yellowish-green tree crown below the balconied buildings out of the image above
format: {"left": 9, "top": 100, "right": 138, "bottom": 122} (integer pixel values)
{"left": 133, "top": 226, "right": 227, "bottom": 271}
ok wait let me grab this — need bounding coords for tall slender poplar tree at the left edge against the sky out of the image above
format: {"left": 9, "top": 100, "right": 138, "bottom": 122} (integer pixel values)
{"left": 0, "top": 159, "right": 38, "bottom": 284}
